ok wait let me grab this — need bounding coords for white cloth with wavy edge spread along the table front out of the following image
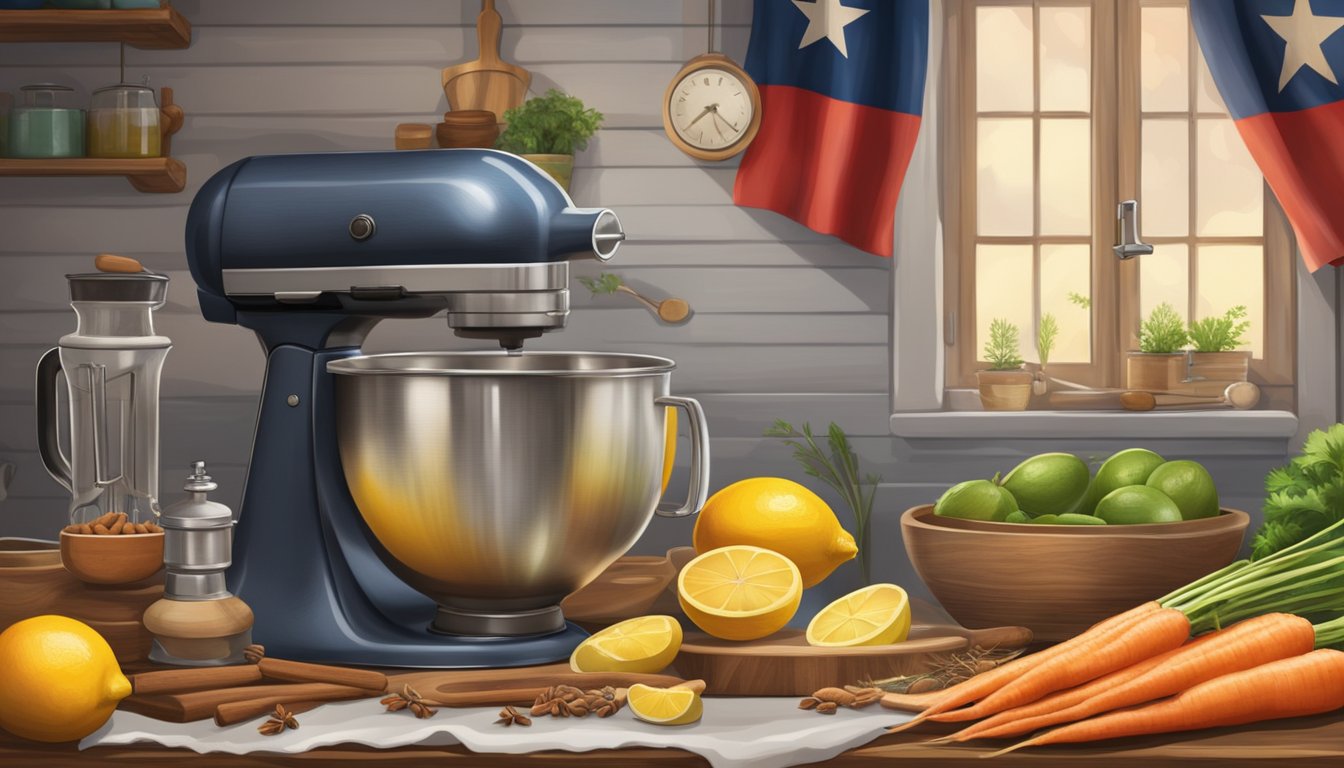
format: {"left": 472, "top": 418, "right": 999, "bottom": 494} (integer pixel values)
{"left": 79, "top": 698, "right": 913, "bottom": 768}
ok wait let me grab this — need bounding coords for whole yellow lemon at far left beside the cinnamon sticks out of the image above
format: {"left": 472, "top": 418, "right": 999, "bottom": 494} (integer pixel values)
{"left": 0, "top": 616, "right": 130, "bottom": 741}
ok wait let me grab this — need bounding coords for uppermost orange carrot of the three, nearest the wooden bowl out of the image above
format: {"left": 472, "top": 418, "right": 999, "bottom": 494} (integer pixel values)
{"left": 929, "top": 608, "right": 1189, "bottom": 722}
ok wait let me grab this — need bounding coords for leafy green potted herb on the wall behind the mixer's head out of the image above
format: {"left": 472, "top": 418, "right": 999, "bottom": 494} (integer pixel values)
{"left": 495, "top": 87, "right": 602, "bottom": 191}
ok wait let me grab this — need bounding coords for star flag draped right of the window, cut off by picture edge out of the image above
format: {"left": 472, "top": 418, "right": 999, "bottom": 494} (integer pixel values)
{"left": 1189, "top": 0, "right": 1344, "bottom": 272}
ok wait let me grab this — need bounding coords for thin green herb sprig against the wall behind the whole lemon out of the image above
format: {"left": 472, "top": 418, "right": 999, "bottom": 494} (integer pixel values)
{"left": 765, "top": 418, "right": 882, "bottom": 584}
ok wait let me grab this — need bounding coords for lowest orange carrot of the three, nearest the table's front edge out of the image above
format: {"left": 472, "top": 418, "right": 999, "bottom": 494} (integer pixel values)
{"left": 993, "top": 650, "right": 1344, "bottom": 755}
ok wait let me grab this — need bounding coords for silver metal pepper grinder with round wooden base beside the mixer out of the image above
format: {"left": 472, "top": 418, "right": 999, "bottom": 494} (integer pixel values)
{"left": 144, "top": 461, "right": 253, "bottom": 667}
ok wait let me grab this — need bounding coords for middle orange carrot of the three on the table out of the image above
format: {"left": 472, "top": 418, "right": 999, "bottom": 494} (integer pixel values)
{"left": 962, "top": 613, "right": 1316, "bottom": 738}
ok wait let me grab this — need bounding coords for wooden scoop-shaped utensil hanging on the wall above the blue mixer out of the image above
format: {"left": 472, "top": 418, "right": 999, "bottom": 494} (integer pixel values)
{"left": 442, "top": 0, "right": 532, "bottom": 121}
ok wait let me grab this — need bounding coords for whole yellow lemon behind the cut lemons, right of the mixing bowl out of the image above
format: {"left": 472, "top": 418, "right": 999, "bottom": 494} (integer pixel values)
{"left": 692, "top": 477, "right": 859, "bottom": 588}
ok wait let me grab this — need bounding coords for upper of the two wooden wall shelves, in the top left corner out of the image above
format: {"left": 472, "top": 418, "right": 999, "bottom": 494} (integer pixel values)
{"left": 0, "top": 7, "right": 191, "bottom": 48}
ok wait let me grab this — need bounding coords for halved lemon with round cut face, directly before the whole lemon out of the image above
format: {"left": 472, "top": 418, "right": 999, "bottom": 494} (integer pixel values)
{"left": 676, "top": 545, "right": 802, "bottom": 640}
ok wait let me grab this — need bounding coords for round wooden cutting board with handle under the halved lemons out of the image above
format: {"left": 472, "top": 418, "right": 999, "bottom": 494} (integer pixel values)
{"left": 673, "top": 624, "right": 1032, "bottom": 695}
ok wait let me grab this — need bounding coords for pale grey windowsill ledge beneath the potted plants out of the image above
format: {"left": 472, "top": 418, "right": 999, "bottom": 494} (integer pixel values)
{"left": 891, "top": 398, "right": 1297, "bottom": 440}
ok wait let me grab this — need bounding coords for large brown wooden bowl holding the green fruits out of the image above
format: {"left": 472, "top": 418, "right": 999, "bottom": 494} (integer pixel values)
{"left": 900, "top": 504, "right": 1250, "bottom": 642}
